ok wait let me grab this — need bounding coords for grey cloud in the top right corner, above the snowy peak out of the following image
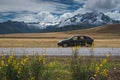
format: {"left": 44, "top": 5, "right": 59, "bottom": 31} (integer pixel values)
{"left": 84, "top": 0, "right": 120, "bottom": 11}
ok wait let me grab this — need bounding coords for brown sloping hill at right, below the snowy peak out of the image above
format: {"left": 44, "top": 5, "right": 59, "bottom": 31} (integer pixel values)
{"left": 66, "top": 24, "right": 120, "bottom": 34}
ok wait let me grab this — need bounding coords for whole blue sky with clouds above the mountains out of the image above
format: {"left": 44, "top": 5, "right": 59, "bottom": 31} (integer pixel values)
{"left": 0, "top": 0, "right": 120, "bottom": 22}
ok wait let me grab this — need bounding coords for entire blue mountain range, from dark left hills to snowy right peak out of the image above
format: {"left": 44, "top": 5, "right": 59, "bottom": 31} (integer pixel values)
{"left": 0, "top": 12, "right": 120, "bottom": 34}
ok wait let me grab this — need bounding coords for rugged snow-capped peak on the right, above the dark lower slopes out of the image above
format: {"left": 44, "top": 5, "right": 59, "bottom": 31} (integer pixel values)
{"left": 59, "top": 12, "right": 118, "bottom": 27}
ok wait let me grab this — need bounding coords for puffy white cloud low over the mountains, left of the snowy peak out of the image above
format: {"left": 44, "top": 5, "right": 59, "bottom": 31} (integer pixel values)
{"left": 12, "top": 11, "right": 58, "bottom": 24}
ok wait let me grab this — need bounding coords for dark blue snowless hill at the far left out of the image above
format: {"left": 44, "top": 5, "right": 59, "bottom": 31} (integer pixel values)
{"left": 0, "top": 21, "right": 38, "bottom": 34}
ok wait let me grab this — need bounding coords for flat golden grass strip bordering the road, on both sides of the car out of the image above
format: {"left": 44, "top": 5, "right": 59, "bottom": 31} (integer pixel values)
{"left": 0, "top": 39, "right": 120, "bottom": 47}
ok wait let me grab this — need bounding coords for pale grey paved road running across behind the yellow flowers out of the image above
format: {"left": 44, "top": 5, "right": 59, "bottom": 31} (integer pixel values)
{"left": 0, "top": 48, "right": 120, "bottom": 56}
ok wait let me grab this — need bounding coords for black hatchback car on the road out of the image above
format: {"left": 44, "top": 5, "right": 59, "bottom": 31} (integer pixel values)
{"left": 58, "top": 36, "right": 94, "bottom": 47}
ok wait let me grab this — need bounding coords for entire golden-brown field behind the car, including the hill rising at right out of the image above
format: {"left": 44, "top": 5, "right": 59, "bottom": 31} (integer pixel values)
{"left": 0, "top": 24, "right": 120, "bottom": 47}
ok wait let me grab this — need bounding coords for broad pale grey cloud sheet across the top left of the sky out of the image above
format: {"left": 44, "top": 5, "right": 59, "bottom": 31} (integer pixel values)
{"left": 0, "top": 0, "right": 67, "bottom": 12}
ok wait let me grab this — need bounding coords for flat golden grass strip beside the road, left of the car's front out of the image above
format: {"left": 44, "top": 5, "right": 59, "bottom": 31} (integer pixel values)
{"left": 0, "top": 39, "right": 58, "bottom": 47}
